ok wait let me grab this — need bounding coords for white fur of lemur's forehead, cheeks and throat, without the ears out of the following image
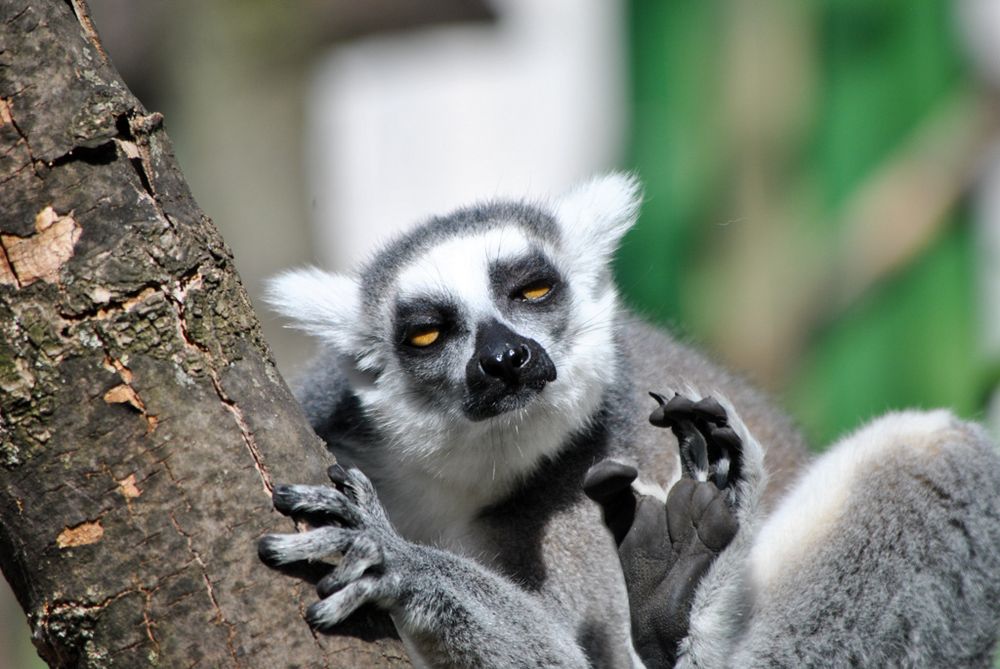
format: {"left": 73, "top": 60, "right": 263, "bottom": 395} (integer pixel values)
{"left": 350, "top": 226, "right": 617, "bottom": 542}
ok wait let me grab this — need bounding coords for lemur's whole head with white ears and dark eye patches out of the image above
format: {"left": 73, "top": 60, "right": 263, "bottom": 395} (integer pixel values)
{"left": 269, "top": 174, "right": 639, "bottom": 470}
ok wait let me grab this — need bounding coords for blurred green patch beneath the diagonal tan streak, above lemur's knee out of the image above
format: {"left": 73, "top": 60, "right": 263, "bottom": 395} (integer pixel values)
{"left": 786, "top": 226, "right": 983, "bottom": 445}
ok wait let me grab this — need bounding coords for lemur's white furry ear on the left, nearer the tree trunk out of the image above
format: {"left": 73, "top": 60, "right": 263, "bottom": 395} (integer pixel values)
{"left": 264, "top": 267, "right": 361, "bottom": 353}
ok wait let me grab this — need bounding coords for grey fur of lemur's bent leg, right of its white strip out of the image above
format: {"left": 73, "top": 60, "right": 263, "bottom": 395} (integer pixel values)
{"left": 716, "top": 420, "right": 1000, "bottom": 669}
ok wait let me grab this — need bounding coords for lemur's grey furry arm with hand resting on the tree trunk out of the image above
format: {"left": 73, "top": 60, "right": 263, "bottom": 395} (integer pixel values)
{"left": 259, "top": 465, "right": 589, "bottom": 667}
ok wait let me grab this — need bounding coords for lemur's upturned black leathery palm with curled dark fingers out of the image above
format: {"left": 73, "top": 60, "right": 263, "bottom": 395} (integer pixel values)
{"left": 584, "top": 394, "right": 741, "bottom": 667}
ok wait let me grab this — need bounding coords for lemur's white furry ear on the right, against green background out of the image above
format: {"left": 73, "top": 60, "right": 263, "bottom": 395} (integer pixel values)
{"left": 555, "top": 172, "right": 642, "bottom": 263}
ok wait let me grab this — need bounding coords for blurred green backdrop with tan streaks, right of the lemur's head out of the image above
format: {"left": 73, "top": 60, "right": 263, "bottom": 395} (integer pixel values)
{"left": 616, "top": 0, "right": 986, "bottom": 445}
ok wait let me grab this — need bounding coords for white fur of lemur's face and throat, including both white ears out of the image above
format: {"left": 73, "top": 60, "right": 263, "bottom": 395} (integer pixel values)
{"left": 268, "top": 175, "right": 638, "bottom": 544}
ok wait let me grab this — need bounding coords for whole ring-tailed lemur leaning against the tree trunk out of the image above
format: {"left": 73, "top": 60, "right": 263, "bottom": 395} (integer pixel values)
{"left": 260, "top": 175, "right": 1000, "bottom": 667}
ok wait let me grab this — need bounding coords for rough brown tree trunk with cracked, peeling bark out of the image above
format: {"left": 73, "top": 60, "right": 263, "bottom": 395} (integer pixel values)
{"left": 0, "top": 0, "right": 406, "bottom": 667}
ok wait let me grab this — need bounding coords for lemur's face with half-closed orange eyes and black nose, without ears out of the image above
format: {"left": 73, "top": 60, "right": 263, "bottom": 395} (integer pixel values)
{"left": 391, "top": 230, "right": 574, "bottom": 421}
